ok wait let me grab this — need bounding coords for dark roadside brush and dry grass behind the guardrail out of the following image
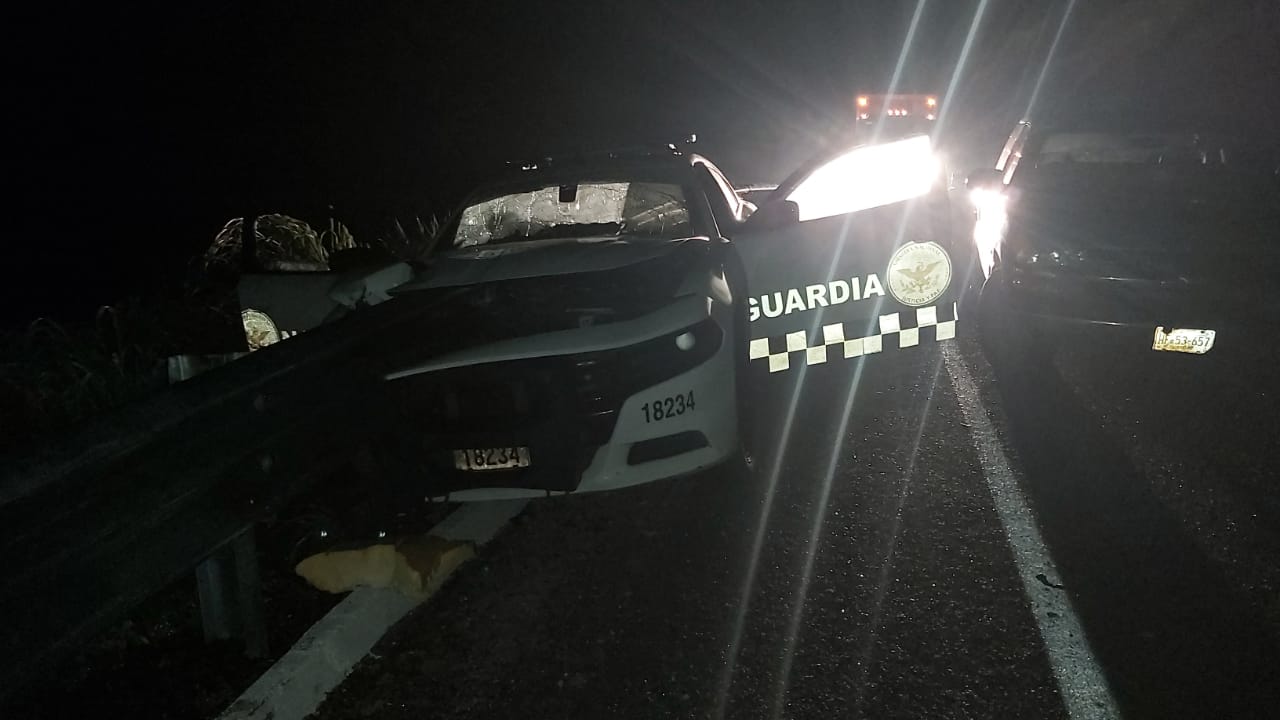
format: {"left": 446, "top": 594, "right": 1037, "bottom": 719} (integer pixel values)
{"left": 0, "top": 214, "right": 439, "bottom": 455}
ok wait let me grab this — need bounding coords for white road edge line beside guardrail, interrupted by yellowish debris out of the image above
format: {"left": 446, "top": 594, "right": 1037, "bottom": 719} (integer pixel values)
{"left": 218, "top": 500, "right": 529, "bottom": 720}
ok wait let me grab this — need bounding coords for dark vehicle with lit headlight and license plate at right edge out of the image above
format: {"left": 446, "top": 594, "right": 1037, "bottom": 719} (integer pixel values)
{"left": 969, "top": 122, "right": 1280, "bottom": 360}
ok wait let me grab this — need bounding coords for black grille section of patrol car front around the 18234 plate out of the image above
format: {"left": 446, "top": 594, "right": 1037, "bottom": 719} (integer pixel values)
{"left": 373, "top": 319, "right": 723, "bottom": 493}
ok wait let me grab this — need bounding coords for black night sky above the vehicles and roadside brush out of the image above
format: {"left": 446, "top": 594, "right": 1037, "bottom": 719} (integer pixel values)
{"left": 3, "top": 0, "right": 1280, "bottom": 327}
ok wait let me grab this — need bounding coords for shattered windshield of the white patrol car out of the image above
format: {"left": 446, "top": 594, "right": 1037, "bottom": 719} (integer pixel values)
{"left": 453, "top": 182, "right": 691, "bottom": 247}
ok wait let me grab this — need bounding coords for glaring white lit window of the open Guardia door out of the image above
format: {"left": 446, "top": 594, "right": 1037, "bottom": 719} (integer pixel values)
{"left": 787, "top": 136, "right": 940, "bottom": 222}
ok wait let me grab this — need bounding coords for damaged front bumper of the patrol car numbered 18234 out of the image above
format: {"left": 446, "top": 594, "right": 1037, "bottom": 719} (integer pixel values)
{"left": 380, "top": 299, "right": 737, "bottom": 501}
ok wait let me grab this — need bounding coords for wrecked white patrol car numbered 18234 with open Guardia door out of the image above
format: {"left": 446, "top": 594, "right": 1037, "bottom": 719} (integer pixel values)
{"left": 241, "top": 136, "right": 955, "bottom": 501}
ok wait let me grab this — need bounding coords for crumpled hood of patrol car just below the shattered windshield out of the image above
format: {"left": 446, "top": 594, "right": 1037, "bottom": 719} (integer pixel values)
{"left": 396, "top": 236, "right": 705, "bottom": 293}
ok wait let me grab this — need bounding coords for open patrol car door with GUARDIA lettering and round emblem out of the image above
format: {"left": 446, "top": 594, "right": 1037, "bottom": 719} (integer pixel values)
{"left": 732, "top": 136, "right": 961, "bottom": 382}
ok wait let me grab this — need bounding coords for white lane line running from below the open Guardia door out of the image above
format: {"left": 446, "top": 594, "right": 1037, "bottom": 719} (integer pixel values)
{"left": 942, "top": 343, "right": 1121, "bottom": 720}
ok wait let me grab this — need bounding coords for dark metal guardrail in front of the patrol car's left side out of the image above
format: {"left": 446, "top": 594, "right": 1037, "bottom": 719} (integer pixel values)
{"left": 0, "top": 289, "right": 450, "bottom": 697}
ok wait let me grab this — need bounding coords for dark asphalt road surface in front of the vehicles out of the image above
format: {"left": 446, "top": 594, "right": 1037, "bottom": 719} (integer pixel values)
{"left": 319, "top": 340, "right": 1280, "bottom": 720}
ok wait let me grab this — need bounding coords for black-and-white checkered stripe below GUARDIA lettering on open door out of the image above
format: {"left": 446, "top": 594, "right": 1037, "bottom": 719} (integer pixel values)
{"left": 750, "top": 304, "right": 959, "bottom": 373}
